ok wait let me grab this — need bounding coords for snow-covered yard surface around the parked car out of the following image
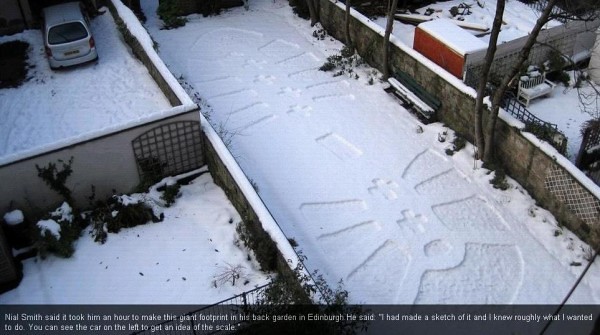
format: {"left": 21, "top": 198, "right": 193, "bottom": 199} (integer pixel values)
{"left": 0, "top": 8, "right": 171, "bottom": 157}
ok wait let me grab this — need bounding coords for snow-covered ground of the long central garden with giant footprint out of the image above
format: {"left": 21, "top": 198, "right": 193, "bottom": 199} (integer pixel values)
{"left": 144, "top": 0, "right": 600, "bottom": 304}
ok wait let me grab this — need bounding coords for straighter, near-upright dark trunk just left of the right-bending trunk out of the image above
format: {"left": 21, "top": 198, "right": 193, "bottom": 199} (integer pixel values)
{"left": 475, "top": 0, "right": 506, "bottom": 158}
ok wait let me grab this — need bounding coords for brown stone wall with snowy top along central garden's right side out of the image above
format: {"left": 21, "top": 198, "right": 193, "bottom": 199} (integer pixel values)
{"left": 320, "top": 0, "right": 600, "bottom": 245}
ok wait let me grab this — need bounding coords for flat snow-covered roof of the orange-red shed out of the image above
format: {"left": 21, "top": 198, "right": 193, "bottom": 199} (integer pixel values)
{"left": 418, "top": 19, "right": 487, "bottom": 55}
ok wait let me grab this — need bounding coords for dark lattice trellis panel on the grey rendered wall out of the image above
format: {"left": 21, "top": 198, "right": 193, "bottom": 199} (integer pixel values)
{"left": 132, "top": 121, "right": 204, "bottom": 181}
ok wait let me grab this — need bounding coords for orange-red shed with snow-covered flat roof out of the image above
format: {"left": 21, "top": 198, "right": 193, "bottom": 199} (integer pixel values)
{"left": 413, "top": 19, "right": 487, "bottom": 79}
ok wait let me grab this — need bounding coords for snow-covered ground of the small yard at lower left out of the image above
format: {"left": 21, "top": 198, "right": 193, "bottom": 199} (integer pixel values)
{"left": 0, "top": 169, "right": 268, "bottom": 304}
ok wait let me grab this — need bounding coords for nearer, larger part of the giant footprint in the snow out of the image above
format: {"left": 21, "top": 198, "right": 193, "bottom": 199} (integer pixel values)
{"left": 300, "top": 147, "right": 524, "bottom": 304}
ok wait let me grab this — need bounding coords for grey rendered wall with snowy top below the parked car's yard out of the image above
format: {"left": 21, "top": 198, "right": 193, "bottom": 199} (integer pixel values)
{"left": 0, "top": 108, "right": 200, "bottom": 218}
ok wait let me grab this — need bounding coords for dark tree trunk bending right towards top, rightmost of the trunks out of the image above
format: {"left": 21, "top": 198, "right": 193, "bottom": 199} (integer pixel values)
{"left": 483, "top": 0, "right": 558, "bottom": 162}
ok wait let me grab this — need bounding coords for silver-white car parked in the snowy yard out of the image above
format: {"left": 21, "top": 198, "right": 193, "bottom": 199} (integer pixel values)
{"left": 43, "top": 2, "right": 98, "bottom": 69}
